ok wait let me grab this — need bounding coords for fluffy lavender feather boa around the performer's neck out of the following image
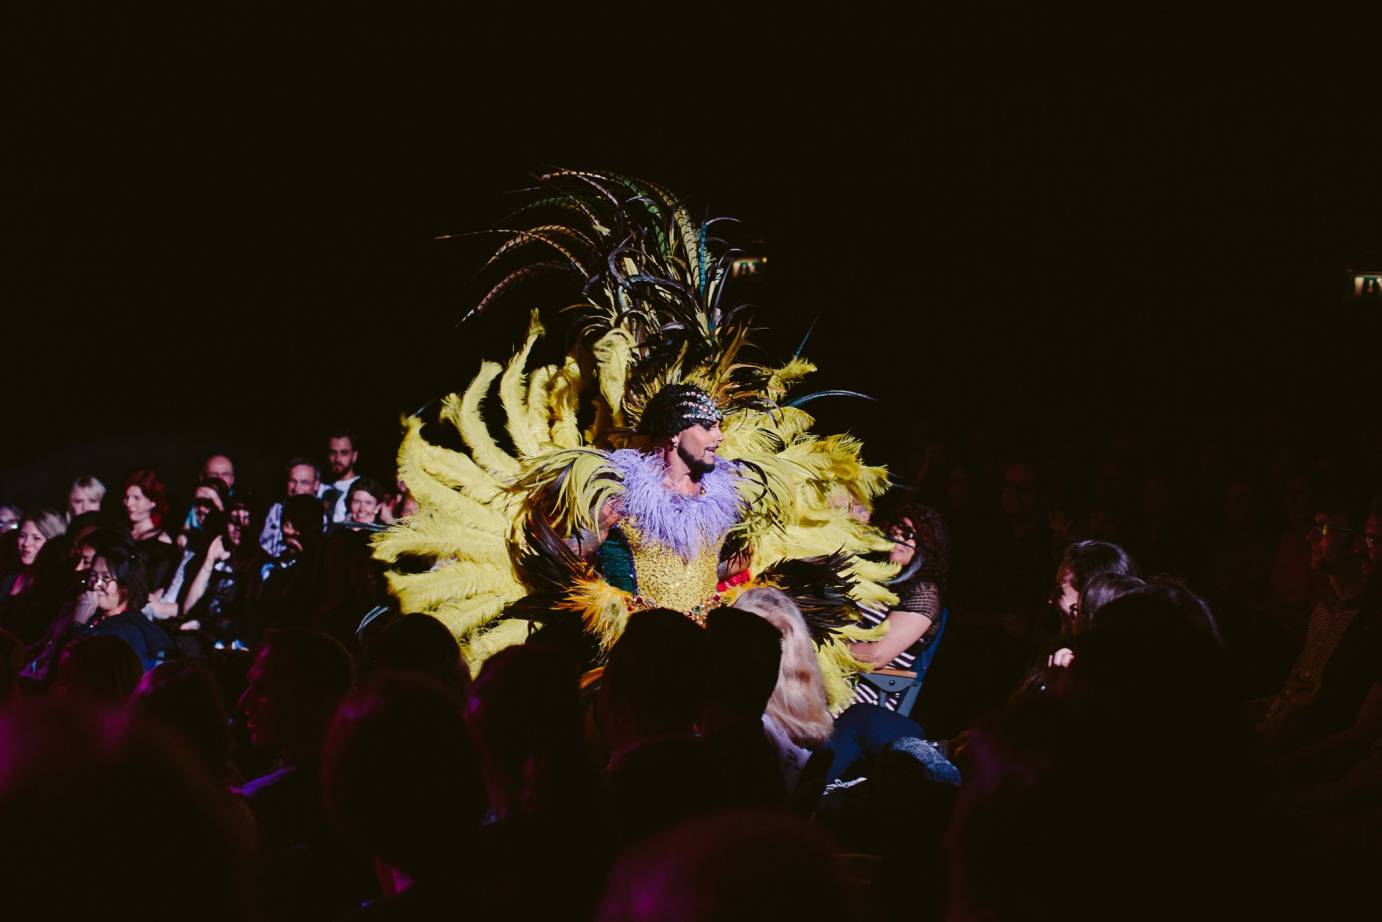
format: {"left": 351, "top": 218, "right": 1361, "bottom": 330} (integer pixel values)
{"left": 609, "top": 448, "right": 742, "bottom": 560}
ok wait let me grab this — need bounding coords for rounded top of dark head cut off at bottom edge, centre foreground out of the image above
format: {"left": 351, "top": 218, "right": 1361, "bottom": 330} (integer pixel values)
{"left": 596, "top": 810, "right": 862, "bottom": 922}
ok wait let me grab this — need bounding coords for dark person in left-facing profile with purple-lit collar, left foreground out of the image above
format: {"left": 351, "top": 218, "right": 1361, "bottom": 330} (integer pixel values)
{"left": 239, "top": 629, "right": 370, "bottom": 919}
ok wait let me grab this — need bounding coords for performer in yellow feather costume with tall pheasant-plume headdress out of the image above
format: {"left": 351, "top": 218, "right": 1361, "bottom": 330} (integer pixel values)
{"left": 375, "top": 170, "right": 896, "bottom": 705}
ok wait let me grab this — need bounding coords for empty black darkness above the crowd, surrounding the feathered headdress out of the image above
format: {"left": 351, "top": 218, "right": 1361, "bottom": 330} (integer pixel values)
{"left": 0, "top": 3, "right": 1382, "bottom": 503}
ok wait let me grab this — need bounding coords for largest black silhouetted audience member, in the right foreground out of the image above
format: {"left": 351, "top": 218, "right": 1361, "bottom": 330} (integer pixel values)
{"left": 947, "top": 587, "right": 1284, "bottom": 919}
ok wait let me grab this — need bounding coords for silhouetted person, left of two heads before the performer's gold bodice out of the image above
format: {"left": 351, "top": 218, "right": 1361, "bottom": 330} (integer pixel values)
{"left": 596, "top": 608, "right": 727, "bottom": 842}
